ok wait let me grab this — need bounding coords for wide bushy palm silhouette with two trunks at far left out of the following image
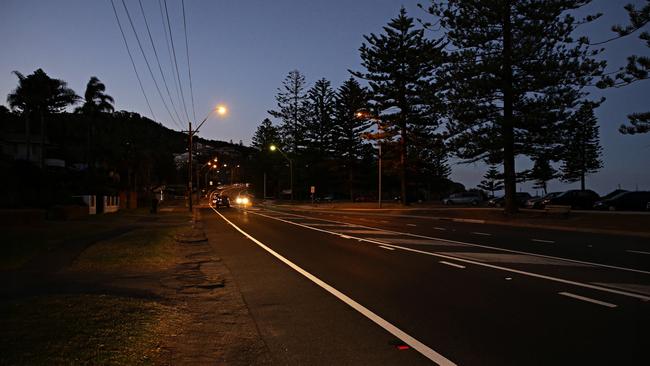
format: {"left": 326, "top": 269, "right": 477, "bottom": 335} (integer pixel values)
{"left": 7, "top": 69, "right": 79, "bottom": 167}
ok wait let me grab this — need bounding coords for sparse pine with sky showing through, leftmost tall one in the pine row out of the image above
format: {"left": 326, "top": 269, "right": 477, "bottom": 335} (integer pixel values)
{"left": 268, "top": 70, "right": 309, "bottom": 153}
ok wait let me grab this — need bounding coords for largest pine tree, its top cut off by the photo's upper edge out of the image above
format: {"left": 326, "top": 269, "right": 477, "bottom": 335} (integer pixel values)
{"left": 428, "top": 0, "right": 606, "bottom": 212}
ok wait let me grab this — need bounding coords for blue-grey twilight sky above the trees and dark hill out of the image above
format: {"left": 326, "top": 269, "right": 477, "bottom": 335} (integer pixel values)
{"left": 0, "top": 0, "right": 650, "bottom": 194}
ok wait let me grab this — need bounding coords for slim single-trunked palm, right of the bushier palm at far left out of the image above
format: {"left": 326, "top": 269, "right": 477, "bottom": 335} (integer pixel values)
{"left": 75, "top": 76, "right": 115, "bottom": 168}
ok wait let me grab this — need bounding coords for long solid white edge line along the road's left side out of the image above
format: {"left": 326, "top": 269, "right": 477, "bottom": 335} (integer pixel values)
{"left": 213, "top": 209, "right": 456, "bottom": 366}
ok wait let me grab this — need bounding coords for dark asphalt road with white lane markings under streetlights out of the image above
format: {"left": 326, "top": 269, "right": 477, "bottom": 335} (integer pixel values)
{"left": 203, "top": 193, "right": 650, "bottom": 365}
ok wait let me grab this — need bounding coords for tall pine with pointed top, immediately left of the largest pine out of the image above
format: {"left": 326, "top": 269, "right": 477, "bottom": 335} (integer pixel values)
{"left": 351, "top": 8, "right": 443, "bottom": 204}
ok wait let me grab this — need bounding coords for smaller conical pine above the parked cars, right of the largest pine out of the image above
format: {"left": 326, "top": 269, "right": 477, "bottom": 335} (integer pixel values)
{"left": 562, "top": 102, "right": 603, "bottom": 190}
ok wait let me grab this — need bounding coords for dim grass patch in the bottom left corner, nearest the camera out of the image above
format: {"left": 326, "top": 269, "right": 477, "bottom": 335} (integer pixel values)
{"left": 0, "top": 295, "right": 170, "bottom": 365}
